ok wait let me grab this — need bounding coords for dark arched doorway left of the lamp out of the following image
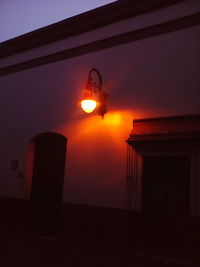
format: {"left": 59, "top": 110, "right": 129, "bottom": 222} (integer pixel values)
{"left": 30, "top": 133, "right": 67, "bottom": 235}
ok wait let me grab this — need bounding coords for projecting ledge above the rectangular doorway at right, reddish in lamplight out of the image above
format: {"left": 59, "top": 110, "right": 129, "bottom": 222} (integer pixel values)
{"left": 127, "top": 114, "right": 200, "bottom": 144}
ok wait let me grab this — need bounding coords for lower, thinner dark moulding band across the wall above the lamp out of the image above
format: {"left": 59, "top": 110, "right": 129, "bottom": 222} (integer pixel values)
{"left": 0, "top": 12, "right": 200, "bottom": 76}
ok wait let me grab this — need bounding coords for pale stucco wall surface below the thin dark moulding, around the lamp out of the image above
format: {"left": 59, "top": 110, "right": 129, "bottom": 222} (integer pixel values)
{"left": 0, "top": 2, "right": 200, "bottom": 207}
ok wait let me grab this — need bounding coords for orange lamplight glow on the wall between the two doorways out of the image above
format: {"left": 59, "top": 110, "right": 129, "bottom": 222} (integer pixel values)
{"left": 53, "top": 109, "right": 142, "bottom": 207}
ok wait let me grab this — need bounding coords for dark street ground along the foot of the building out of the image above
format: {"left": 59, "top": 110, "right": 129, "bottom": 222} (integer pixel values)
{"left": 0, "top": 233, "right": 200, "bottom": 267}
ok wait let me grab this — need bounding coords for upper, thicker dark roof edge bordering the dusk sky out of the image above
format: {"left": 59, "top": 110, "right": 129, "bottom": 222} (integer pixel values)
{"left": 0, "top": 0, "right": 184, "bottom": 58}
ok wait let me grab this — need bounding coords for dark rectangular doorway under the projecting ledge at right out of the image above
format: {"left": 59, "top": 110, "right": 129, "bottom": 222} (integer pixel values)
{"left": 142, "top": 156, "right": 190, "bottom": 244}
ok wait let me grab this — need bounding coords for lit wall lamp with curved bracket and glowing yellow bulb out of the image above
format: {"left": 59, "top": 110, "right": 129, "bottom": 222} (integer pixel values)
{"left": 81, "top": 68, "right": 108, "bottom": 119}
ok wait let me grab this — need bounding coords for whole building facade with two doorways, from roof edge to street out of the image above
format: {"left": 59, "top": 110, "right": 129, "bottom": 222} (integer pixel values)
{"left": 0, "top": 0, "right": 200, "bottom": 247}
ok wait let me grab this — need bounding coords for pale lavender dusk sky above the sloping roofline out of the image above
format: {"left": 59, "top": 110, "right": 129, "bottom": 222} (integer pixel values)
{"left": 0, "top": 0, "right": 116, "bottom": 42}
